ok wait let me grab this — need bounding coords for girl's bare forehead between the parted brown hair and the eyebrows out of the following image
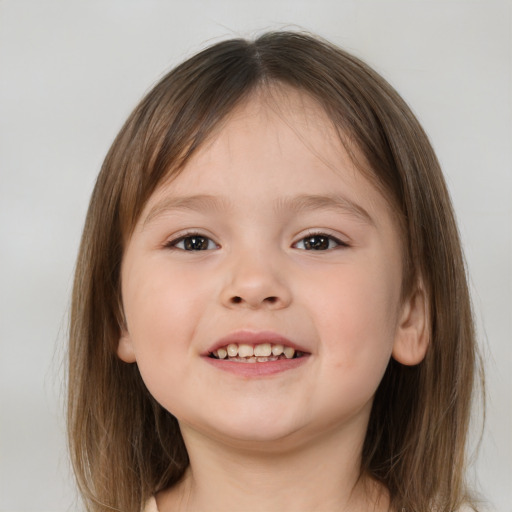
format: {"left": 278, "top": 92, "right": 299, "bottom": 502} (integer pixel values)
{"left": 143, "top": 85, "right": 387, "bottom": 226}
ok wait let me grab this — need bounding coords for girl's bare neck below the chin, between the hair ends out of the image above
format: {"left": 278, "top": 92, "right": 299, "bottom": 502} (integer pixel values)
{"left": 157, "top": 418, "right": 388, "bottom": 512}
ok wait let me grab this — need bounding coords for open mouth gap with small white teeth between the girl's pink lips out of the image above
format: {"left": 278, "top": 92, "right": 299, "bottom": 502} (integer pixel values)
{"left": 209, "top": 343, "right": 305, "bottom": 363}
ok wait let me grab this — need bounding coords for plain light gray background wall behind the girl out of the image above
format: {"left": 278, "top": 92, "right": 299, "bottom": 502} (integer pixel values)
{"left": 0, "top": 0, "right": 512, "bottom": 512}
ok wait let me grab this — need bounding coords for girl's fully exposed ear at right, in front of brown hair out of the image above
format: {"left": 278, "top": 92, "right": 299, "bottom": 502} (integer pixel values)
{"left": 392, "top": 283, "right": 430, "bottom": 366}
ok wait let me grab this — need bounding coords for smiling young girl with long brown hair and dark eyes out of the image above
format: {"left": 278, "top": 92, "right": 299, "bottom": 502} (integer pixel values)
{"left": 69, "top": 32, "right": 476, "bottom": 512}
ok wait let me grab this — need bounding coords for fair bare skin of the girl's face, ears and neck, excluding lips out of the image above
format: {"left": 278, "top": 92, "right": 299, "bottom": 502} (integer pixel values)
{"left": 118, "top": 89, "right": 427, "bottom": 512}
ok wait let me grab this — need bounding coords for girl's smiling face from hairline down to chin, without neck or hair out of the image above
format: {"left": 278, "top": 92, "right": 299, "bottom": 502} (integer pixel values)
{"left": 118, "top": 90, "right": 424, "bottom": 450}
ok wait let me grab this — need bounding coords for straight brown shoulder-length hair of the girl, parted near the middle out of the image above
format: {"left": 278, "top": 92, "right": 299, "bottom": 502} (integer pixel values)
{"left": 68, "top": 32, "right": 476, "bottom": 512}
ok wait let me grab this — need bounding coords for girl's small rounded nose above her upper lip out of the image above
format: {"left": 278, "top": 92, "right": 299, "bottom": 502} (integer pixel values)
{"left": 221, "top": 252, "right": 292, "bottom": 310}
